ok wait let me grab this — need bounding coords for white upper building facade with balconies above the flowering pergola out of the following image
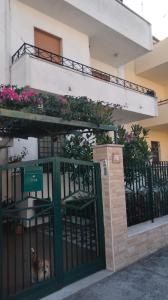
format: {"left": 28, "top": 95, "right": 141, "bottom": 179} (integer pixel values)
{"left": 0, "top": 0, "right": 158, "bottom": 159}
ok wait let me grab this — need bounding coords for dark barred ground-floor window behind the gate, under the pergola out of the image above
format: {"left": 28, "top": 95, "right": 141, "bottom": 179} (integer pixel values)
{"left": 38, "top": 136, "right": 65, "bottom": 158}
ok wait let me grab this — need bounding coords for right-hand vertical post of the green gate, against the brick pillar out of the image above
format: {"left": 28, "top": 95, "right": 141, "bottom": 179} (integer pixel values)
{"left": 94, "top": 163, "right": 105, "bottom": 263}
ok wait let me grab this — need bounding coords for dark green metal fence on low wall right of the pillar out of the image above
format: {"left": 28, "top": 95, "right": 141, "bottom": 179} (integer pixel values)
{"left": 124, "top": 162, "right": 168, "bottom": 226}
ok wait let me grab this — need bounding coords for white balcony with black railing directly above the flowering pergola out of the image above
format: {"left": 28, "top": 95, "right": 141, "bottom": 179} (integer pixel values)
{"left": 11, "top": 44, "right": 157, "bottom": 122}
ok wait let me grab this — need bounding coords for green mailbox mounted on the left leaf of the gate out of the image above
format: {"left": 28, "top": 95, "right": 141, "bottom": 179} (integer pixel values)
{"left": 21, "top": 166, "right": 43, "bottom": 193}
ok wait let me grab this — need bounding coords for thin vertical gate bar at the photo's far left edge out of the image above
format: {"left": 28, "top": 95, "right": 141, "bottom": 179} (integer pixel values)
{"left": 0, "top": 170, "right": 3, "bottom": 299}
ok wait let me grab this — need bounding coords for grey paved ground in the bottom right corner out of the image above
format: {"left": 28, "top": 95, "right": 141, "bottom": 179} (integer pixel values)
{"left": 66, "top": 248, "right": 168, "bottom": 300}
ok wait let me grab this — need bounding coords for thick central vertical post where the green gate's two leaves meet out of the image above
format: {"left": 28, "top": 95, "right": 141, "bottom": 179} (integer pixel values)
{"left": 53, "top": 158, "right": 63, "bottom": 285}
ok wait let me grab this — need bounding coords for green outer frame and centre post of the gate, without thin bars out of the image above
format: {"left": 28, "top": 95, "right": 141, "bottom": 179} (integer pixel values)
{"left": 0, "top": 157, "right": 106, "bottom": 300}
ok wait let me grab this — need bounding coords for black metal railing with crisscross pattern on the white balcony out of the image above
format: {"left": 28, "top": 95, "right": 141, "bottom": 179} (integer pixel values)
{"left": 12, "top": 43, "right": 155, "bottom": 97}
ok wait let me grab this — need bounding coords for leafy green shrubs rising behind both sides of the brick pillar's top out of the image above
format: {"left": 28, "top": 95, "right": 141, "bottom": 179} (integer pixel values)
{"left": 60, "top": 124, "right": 151, "bottom": 163}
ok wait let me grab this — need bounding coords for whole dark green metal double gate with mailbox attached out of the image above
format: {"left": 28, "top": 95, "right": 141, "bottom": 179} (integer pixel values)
{"left": 0, "top": 157, "right": 105, "bottom": 300}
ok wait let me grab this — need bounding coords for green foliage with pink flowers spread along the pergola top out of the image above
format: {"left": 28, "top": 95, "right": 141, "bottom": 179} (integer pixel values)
{"left": 0, "top": 85, "right": 119, "bottom": 125}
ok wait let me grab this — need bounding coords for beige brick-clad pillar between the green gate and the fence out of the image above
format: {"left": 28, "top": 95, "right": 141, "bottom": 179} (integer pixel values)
{"left": 93, "top": 145, "right": 128, "bottom": 271}
